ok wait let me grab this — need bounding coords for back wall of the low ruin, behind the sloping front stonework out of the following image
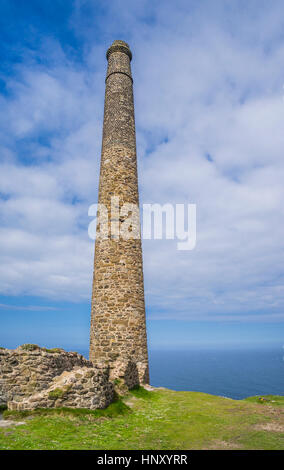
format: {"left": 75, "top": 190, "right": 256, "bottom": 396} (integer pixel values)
{"left": 0, "top": 345, "right": 92, "bottom": 405}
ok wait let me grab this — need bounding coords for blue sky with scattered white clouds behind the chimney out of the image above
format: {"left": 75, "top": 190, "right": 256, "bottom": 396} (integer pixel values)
{"left": 0, "top": 0, "right": 284, "bottom": 349}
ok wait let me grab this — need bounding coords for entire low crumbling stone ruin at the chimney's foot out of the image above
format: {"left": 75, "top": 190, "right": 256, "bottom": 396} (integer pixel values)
{"left": 0, "top": 345, "right": 141, "bottom": 410}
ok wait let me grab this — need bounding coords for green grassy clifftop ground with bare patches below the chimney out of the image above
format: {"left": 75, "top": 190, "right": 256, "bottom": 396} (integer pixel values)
{"left": 0, "top": 388, "right": 284, "bottom": 450}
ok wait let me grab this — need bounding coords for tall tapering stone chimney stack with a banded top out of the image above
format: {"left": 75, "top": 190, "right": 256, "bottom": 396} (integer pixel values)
{"left": 90, "top": 41, "right": 149, "bottom": 383}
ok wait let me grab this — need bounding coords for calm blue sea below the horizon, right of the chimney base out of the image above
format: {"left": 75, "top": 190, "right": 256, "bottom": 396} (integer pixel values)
{"left": 78, "top": 348, "right": 284, "bottom": 400}
